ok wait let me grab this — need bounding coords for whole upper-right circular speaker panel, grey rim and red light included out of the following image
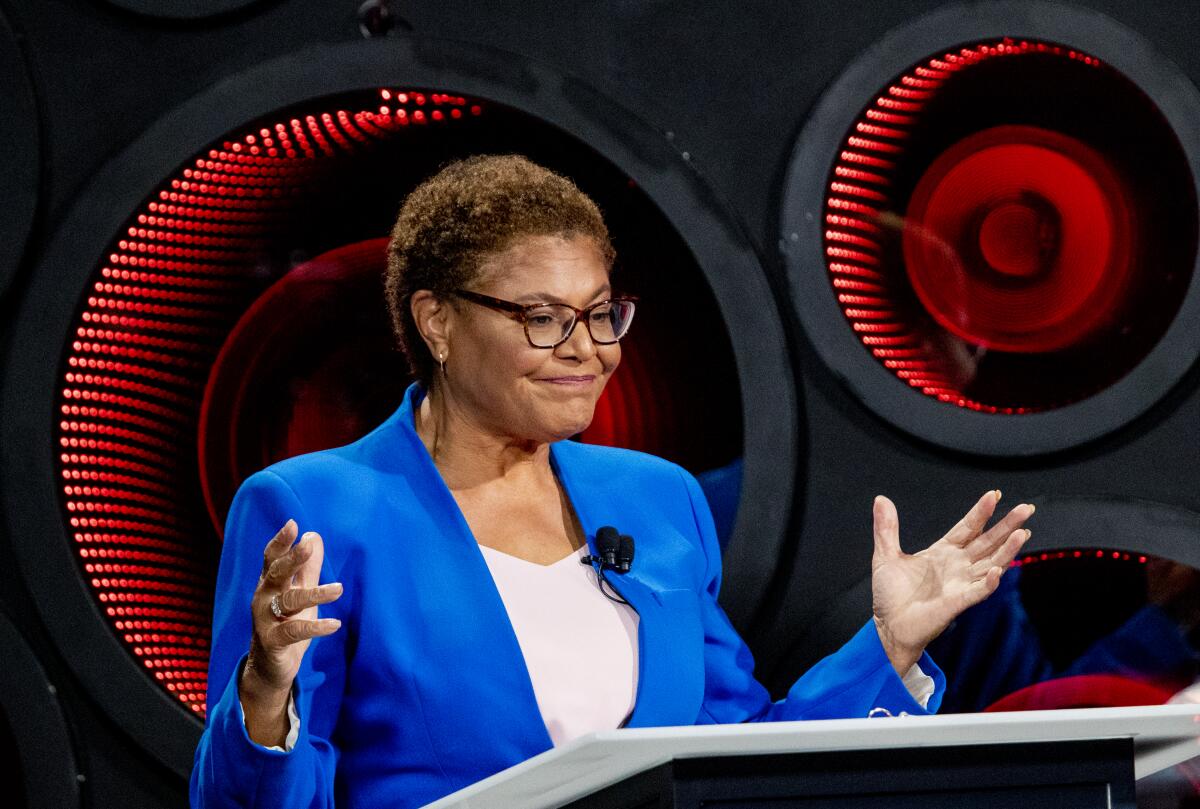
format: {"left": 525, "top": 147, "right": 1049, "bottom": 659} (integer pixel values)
{"left": 780, "top": 2, "right": 1200, "bottom": 455}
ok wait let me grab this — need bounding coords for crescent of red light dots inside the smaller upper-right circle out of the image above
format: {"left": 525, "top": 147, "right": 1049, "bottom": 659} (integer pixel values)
{"left": 824, "top": 38, "right": 1100, "bottom": 414}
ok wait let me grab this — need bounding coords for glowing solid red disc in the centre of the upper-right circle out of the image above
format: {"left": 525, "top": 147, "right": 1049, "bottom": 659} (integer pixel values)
{"left": 904, "top": 126, "right": 1134, "bottom": 354}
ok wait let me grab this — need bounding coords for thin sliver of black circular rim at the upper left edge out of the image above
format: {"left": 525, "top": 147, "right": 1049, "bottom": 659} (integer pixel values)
{"left": 0, "top": 3, "right": 42, "bottom": 296}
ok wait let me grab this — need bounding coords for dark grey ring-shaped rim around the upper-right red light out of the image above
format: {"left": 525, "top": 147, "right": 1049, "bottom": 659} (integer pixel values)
{"left": 779, "top": 0, "right": 1200, "bottom": 456}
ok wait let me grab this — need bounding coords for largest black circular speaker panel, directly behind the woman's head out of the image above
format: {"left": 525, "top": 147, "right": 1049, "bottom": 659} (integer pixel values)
{"left": 2, "top": 38, "right": 798, "bottom": 773}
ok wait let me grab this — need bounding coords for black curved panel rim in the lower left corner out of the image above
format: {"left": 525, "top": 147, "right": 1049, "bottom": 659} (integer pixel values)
{"left": 0, "top": 612, "right": 80, "bottom": 809}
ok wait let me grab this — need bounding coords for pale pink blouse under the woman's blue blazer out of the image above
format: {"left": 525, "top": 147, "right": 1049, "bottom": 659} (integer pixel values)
{"left": 479, "top": 545, "right": 637, "bottom": 747}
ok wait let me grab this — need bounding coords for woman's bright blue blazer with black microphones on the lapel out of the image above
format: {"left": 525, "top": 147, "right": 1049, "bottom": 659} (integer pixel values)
{"left": 191, "top": 384, "right": 944, "bottom": 809}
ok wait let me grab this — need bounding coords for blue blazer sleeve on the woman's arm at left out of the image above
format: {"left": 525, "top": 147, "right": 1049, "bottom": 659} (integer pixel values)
{"left": 190, "top": 471, "right": 347, "bottom": 809}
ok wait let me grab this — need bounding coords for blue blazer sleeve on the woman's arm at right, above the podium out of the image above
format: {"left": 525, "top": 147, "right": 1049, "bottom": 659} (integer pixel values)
{"left": 679, "top": 469, "right": 946, "bottom": 724}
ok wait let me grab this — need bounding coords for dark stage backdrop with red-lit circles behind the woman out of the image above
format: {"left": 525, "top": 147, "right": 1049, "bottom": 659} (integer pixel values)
{"left": 0, "top": 0, "right": 1200, "bottom": 807}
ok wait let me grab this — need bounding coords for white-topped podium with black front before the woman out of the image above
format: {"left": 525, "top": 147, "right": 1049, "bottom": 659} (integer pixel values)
{"left": 430, "top": 705, "right": 1200, "bottom": 809}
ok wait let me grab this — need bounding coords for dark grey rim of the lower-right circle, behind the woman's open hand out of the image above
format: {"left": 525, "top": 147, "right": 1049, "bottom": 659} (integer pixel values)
{"left": 779, "top": 495, "right": 1200, "bottom": 686}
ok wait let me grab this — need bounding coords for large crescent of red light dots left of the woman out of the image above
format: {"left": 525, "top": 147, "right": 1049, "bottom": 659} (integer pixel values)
{"left": 58, "top": 90, "right": 482, "bottom": 715}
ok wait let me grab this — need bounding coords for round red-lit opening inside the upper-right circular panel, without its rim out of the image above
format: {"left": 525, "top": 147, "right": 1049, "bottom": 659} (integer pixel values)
{"left": 823, "top": 38, "right": 1196, "bottom": 414}
